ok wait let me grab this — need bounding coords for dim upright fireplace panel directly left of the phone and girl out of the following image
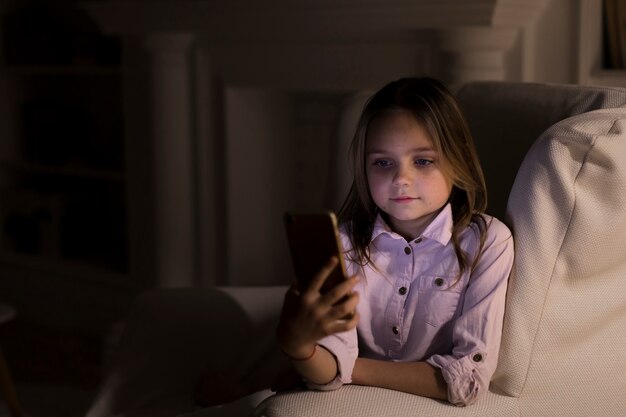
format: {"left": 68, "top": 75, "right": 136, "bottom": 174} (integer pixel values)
{"left": 224, "top": 88, "right": 295, "bottom": 285}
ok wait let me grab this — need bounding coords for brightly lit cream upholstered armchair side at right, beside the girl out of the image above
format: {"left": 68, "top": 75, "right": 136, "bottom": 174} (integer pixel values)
{"left": 493, "top": 107, "right": 626, "bottom": 416}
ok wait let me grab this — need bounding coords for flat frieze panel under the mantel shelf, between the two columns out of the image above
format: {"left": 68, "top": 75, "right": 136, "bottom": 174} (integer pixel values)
{"left": 206, "top": 40, "right": 432, "bottom": 92}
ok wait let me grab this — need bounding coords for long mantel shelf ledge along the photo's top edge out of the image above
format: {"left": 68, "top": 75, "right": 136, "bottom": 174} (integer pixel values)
{"left": 83, "top": 0, "right": 546, "bottom": 42}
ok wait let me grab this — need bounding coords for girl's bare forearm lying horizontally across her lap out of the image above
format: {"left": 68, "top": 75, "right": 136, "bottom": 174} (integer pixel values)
{"left": 352, "top": 358, "right": 448, "bottom": 400}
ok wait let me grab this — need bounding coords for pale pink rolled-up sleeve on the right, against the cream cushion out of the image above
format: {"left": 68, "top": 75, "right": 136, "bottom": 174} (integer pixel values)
{"left": 427, "top": 220, "right": 513, "bottom": 406}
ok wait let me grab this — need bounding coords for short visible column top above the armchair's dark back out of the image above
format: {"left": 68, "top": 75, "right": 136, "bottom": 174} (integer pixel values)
{"left": 438, "top": 27, "right": 519, "bottom": 85}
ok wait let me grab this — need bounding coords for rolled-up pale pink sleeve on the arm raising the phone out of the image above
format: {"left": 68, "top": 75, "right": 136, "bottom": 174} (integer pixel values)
{"left": 307, "top": 329, "right": 359, "bottom": 391}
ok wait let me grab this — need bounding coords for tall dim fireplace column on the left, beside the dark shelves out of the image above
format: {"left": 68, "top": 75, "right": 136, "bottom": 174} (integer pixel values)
{"left": 142, "top": 33, "right": 196, "bottom": 287}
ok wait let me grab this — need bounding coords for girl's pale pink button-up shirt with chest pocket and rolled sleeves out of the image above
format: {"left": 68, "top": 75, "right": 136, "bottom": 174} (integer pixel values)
{"left": 312, "top": 205, "right": 513, "bottom": 405}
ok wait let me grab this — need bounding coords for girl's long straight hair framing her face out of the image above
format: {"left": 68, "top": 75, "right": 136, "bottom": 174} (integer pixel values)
{"left": 339, "top": 77, "right": 487, "bottom": 277}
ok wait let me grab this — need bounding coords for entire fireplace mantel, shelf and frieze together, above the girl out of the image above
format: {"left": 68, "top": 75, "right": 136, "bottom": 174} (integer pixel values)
{"left": 82, "top": 0, "right": 549, "bottom": 89}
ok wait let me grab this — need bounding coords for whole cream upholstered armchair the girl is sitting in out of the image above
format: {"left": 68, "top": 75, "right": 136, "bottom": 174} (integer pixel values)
{"left": 88, "top": 82, "right": 626, "bottom": 417}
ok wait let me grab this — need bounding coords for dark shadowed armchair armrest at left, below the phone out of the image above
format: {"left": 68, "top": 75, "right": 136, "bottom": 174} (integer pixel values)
{"left": 87, "top": 287, "right": 285, "bottom": 417}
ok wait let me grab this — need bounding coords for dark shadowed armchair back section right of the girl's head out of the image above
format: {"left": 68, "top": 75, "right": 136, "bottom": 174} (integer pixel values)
{"left": 457, "top": 81, "right": 626, "bottom": 218}
